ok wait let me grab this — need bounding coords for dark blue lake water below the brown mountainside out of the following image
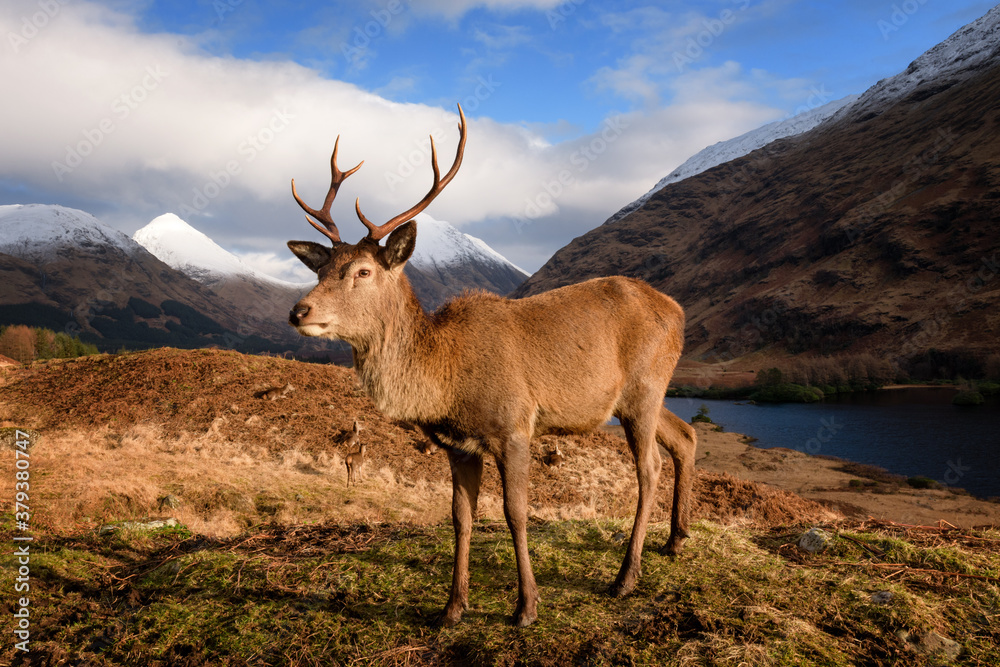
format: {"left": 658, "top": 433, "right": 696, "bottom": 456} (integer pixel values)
{"left": 666, "top": 388, "right": 1000, "bottom": 497}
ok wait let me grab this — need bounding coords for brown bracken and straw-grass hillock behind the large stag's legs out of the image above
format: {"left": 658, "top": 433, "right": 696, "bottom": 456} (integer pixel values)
{"left": 0, "top": 348, "right": 836, "bottom": 532}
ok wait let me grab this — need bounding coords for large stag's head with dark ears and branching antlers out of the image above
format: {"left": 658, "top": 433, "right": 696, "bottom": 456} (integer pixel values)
{"left": 288, "top": 106, "right": 466, "bottom": 344}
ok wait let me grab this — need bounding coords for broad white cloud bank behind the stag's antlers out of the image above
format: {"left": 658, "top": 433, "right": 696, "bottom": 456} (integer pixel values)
{"left": 0, "top": 0, "right": 796, "bottom": 276}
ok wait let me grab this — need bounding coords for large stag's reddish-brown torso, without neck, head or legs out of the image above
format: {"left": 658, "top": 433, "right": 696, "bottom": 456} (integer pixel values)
{"left": 437, "top": 277, "right": 684, "bottom": 432}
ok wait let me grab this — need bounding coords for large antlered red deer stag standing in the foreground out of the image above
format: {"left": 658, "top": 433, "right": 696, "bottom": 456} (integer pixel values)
{"left": 288, "top": 106, "right": 695, "bottom": 626}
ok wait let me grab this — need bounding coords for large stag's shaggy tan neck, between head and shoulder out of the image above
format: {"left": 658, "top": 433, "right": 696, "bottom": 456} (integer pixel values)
{"left": 354, "top": 276, "right": 452, "bottom": 424}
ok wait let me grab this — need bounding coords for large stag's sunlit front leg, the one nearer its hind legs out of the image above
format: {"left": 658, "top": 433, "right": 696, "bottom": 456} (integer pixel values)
{"left": 497, "top": 438, "right": 538, "bottom": 628}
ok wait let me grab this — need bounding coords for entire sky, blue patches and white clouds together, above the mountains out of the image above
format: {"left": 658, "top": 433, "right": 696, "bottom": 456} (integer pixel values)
{"left": 0, "top": 0, "right": 992, "bottom": 277}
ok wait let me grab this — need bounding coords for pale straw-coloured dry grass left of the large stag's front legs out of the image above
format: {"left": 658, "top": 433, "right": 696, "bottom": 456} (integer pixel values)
{"left": 11, "top": 425, "right": 460, "bottom": 537}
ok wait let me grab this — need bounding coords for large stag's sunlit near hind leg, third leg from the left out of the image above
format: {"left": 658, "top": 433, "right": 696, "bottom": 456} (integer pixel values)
{"left": 608, "top": 396, "right": 662, "bottom": 597}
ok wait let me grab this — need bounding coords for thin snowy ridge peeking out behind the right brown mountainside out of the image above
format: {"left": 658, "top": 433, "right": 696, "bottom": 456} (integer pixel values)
{"left": 604, "top": 95, "right": 860, "bottom": 224}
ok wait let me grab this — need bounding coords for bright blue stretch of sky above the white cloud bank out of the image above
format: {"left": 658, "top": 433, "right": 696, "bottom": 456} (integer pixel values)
{"left": 129, "top": 0, "right": 993, "bottom": 133}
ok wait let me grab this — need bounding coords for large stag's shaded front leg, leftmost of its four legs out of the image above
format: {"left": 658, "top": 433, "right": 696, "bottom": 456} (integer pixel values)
{"left": 441, "top": 448, "right": 483, "bottom": 627}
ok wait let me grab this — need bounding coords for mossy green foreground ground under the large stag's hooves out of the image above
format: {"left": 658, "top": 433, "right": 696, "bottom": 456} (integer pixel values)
{"left": 0, "top": 520, "right": 1000, "bottom": 666}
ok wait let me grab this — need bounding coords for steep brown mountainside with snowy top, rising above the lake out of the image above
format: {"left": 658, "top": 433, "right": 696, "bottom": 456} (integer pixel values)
{"left": 516, "top": 8, "right": 1000, "bottom": 376}
